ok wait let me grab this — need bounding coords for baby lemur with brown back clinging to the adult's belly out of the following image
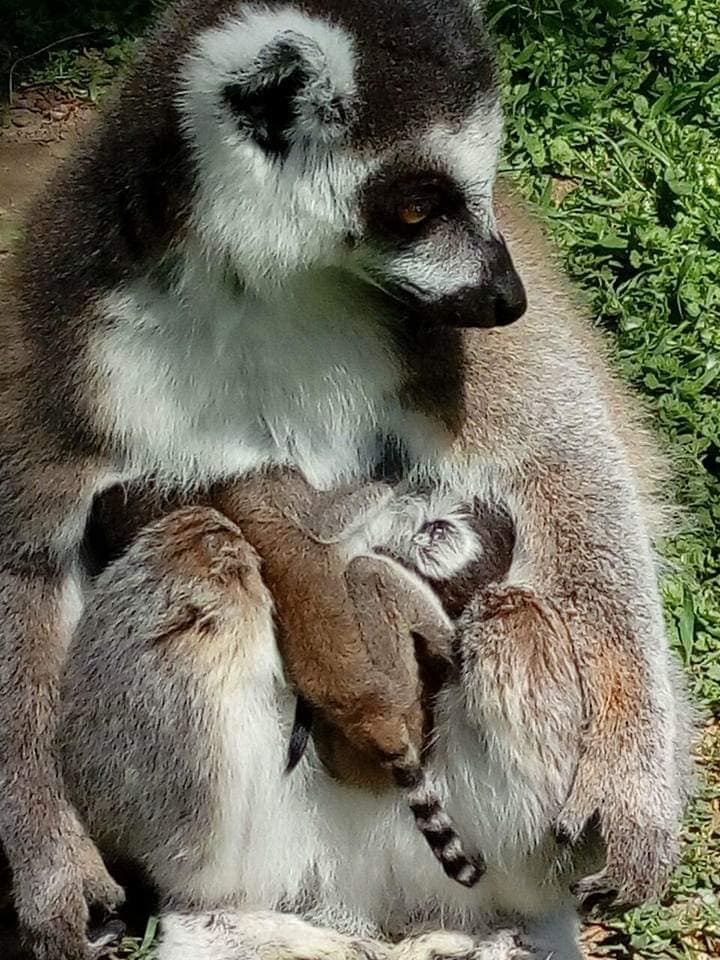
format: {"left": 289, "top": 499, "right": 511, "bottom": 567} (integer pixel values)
{"left": 208, "top": 470, "right": 492, "bottom": 887}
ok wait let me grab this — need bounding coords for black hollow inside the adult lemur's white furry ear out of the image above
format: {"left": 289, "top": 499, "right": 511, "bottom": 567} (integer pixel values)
{"left": 223, "top": 64, "right": 309, "bottom": 160}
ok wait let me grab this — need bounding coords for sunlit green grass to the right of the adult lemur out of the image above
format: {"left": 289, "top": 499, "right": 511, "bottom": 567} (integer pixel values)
{"left": 12, "top": 0, "right": 720, "bottom": 960}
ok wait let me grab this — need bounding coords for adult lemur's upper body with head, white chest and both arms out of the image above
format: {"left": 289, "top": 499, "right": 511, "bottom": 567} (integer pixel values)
{"left": 0, "top": 0, "right": 682, "bottom": 960}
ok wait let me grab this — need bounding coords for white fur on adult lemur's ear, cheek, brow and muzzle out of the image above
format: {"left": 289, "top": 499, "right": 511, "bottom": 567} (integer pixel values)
{"left": 179, "top": 7, "right": 502, "bottom": 301}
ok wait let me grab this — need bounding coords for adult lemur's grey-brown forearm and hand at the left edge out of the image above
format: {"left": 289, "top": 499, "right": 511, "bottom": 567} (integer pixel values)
{"left": 0, "top": 452, "right": 122, "bottom": 960}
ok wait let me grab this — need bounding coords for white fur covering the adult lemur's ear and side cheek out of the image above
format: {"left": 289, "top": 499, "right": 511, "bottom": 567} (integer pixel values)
{"left": 179, "top": 7, "right": 369, "bottom": 293}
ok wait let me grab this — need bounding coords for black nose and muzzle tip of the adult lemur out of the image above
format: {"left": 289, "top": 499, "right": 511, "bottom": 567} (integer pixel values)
{"left": 430, "top": 238, "right": 527, "bottom": 327}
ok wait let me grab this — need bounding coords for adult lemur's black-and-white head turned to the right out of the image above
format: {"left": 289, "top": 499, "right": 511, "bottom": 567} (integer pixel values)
{"left": 178, "top": 0, "right": 525, "bottom": 326}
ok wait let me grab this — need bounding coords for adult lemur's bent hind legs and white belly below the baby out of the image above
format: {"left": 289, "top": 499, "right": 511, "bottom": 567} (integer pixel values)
{"left": 59, "top": 491, "right": 600, "bottom": 960}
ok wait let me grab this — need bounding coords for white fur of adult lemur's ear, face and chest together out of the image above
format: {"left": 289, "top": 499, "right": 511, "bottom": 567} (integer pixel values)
{"left": 89, "top": 7, "right": 501, "bottom": 485}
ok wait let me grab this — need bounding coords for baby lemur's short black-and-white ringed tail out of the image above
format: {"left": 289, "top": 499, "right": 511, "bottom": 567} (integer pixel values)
{"left": 393, "top": 768, "right": 485, "bottom": 887}
